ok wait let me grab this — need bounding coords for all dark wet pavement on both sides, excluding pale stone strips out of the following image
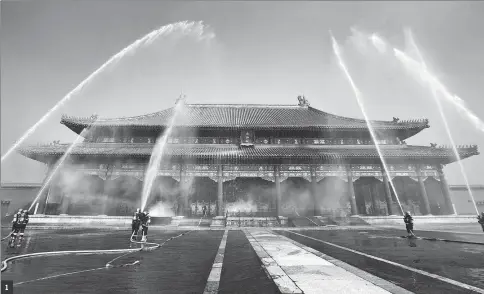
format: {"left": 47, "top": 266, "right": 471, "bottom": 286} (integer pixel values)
{"left": 1, "top": 227, "right": 484, "bottom": 294}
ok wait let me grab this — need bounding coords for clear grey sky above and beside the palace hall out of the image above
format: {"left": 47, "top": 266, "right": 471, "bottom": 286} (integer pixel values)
{"left": 0, "top": 0, "right": 484, "bottom": 184}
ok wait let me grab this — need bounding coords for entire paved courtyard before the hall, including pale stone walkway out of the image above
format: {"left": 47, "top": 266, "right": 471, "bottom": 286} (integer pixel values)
{"left": 2, "top": 227, "right": 484, "bottom": 293}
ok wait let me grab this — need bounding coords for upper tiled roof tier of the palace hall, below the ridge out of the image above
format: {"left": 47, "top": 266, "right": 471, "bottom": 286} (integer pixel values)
{"left": 61, "top": 104, "right": 429, "bottom": 132}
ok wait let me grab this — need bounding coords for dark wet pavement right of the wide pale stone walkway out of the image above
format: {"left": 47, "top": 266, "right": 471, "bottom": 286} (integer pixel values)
{"left": 280, "top": 229, "right": 484, "bottom": 294}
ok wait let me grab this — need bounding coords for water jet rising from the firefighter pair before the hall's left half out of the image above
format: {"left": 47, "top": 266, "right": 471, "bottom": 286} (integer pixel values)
{"left": 141, "top": 100, "right": 184, "bottom": 211}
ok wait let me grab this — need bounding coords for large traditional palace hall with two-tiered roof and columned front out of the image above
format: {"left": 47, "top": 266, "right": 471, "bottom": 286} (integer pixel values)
{"left": 18, "top": 96, "right": 479, "bottom": 217}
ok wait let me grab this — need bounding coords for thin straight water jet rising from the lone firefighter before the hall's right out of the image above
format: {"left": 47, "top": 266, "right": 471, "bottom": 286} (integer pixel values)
{"left": 330, "top": 33, "right": 404, "bottom": 214}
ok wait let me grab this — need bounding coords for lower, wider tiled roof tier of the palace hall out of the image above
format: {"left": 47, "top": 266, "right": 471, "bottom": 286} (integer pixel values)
{"left": 19, "top": 143, "right": 479, "bottom": 164}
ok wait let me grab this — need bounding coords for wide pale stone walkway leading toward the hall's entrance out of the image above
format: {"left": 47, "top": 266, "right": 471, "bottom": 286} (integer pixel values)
{"left": 244, "top": 229, "right": 410, "bottom": 294}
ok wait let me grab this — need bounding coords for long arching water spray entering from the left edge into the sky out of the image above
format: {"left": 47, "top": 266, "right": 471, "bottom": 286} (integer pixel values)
{"left": 1, "top": 21, "right": 215, "bottom": 162}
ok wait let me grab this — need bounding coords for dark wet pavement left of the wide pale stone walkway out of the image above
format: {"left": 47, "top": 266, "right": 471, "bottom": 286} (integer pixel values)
{"left": 2, "top": 230, "right": 279, "bottom": 294}
